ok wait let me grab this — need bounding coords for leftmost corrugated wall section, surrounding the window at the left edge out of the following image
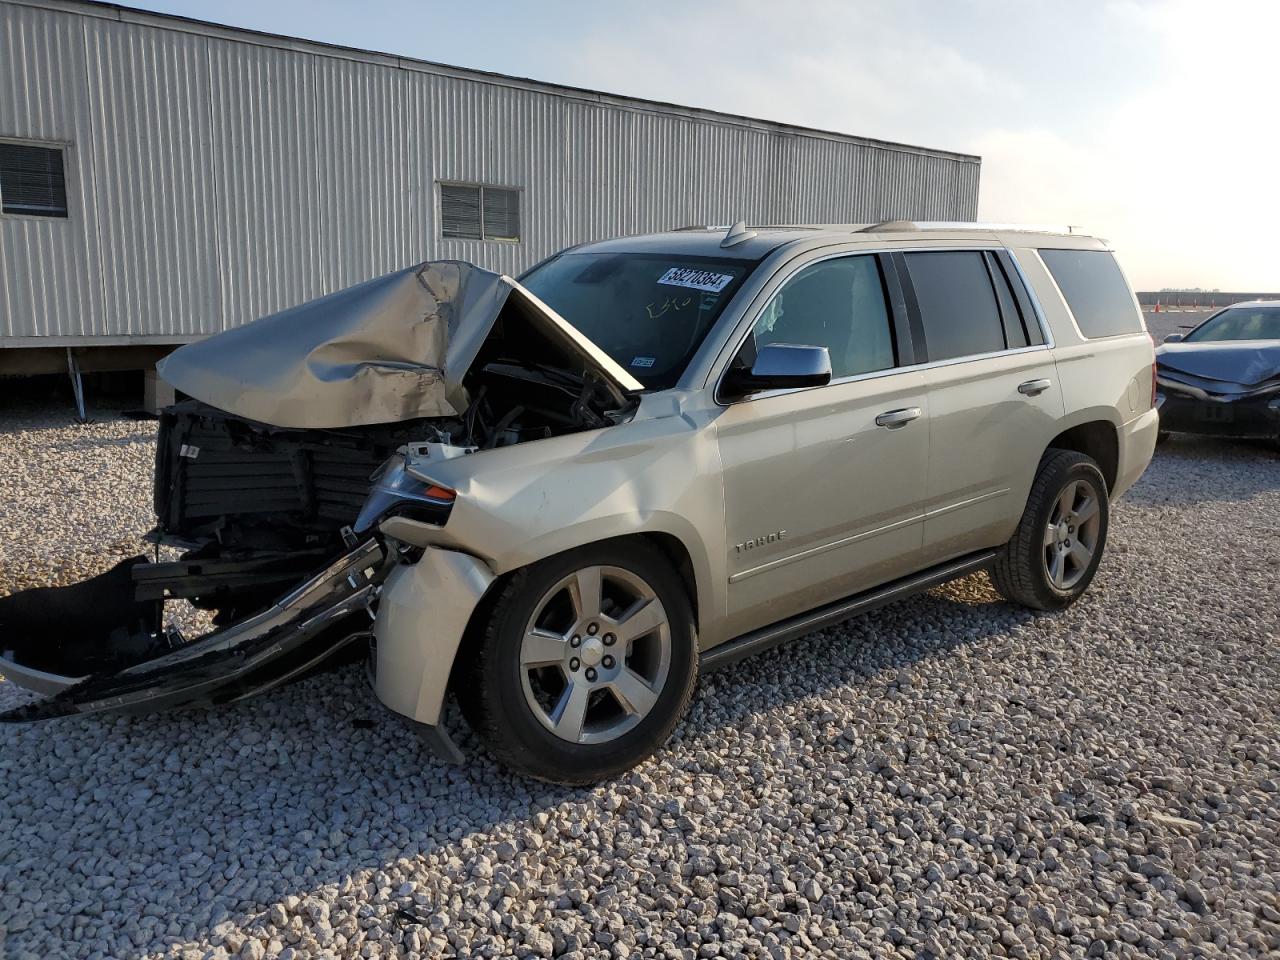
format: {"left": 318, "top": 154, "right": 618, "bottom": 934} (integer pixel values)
{"left": 0, "top": 5, "right": 106, "bottom": 342}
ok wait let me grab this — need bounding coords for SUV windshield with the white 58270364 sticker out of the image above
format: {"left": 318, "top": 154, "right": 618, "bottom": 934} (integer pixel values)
{"left": 520, "top": 253, "right": 755, "bottom": 390}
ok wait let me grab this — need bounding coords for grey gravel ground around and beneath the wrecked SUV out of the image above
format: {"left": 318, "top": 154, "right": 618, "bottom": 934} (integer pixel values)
{"left": 0, "top": 411, "right": 1280, "bottom": 959}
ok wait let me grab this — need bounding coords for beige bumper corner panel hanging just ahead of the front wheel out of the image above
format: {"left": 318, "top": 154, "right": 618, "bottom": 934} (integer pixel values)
{"left": 374, "top": 547, "right": 495, "bottom": 726}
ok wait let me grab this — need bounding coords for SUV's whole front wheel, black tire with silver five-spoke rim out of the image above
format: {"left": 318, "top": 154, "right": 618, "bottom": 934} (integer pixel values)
{"left": 456, "top": 539, "right": 698, "bottom": 786}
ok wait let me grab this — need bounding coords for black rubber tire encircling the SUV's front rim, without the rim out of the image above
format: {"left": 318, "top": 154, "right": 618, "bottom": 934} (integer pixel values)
{"left": 479, "top": 543, "right": 698, "bottom": 782}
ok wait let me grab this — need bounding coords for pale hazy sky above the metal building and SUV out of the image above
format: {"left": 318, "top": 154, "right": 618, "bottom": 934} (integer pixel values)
{"left": 133, "top": 0, "right": 1280, "bottom": 292}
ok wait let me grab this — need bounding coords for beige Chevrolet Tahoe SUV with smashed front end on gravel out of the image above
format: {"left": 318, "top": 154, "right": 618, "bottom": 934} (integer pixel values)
{"left": 0, "top": 221, "right": 1157, "bottom": 783}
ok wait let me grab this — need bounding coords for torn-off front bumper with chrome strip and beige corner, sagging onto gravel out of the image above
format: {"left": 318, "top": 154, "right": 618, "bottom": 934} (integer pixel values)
{"left": 0, "top": 535, "right": 494, "bottom": 762}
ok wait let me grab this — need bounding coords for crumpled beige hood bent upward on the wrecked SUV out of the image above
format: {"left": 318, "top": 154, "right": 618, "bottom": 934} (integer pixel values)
{"left": 156, "top": 260, "right": 643, "bottom": 429}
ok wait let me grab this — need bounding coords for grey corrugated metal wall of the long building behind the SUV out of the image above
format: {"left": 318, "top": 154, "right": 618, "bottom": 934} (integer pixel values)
{"left": 0, "top": 0, "right": 979, "bottom": 347}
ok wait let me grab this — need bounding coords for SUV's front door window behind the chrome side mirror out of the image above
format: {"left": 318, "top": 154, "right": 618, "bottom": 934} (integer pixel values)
{"left": 751, "top": 256, "right": 893, "bottom": 379}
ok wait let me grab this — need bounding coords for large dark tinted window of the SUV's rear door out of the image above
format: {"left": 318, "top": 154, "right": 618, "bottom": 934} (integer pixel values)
{"left": 906, "top": 251, "right": 1005, "bottom": 361}
